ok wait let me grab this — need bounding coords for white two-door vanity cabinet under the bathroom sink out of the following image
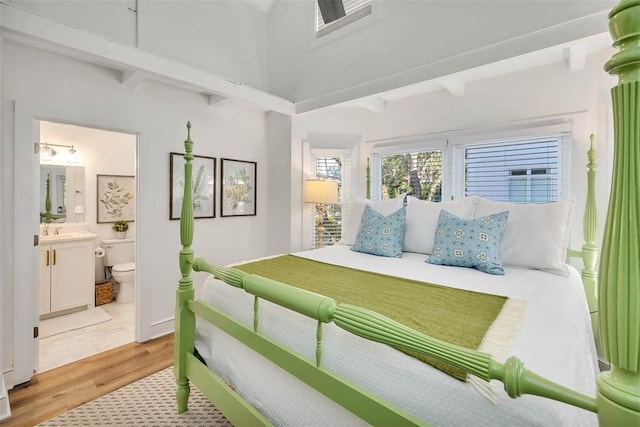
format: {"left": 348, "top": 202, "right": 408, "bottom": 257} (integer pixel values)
{"left": 40, "top": 233, "right": 95, "bottom": 318}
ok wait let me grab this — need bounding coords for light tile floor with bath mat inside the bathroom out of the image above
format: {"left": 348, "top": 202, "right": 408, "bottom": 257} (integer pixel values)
{"left": 36, "top": 301, "right": 136, "bottom": 372}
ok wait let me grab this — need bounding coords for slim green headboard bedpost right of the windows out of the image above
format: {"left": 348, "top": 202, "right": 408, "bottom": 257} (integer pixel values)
{"left": 582, "top": 134, "right": 600, "bottom": 354}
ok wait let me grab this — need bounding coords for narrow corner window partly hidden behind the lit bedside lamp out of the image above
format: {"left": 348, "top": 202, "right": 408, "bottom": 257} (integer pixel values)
{"left": 312, "top": 150, "right": 351, "bottom": 248}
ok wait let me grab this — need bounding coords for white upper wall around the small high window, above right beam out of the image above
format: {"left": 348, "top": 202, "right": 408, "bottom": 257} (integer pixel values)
{"left": 269, "top": 0, "right": 617, "bottom": 102}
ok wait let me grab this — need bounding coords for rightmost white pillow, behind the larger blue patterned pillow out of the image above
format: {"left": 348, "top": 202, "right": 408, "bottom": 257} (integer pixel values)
{"left": 475, "top": 198, "right": 575, "bottom": 276}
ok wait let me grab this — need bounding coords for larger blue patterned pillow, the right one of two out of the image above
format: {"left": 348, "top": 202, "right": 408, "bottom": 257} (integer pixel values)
{"left": 426, "top": 209, "right": 509, "bottom": 275}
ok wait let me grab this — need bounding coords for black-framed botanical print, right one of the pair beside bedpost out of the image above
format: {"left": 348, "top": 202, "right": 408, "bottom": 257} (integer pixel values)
{"left": 220, "top": 159, "right": 258, "bottom": 217}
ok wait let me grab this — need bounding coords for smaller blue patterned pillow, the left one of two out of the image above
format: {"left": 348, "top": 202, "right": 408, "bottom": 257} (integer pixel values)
{"left": 351, "top": 205, "right": 407, "bottom": 258}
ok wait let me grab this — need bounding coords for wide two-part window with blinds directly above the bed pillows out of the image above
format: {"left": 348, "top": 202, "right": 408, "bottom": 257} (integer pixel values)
{"left": 372, "top": 134, "right": 570, "bottom": 203}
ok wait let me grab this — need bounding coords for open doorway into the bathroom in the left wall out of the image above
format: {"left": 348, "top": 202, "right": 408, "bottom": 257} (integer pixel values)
{"left": 36, "top": 121, "right": 137, "bottom": 372}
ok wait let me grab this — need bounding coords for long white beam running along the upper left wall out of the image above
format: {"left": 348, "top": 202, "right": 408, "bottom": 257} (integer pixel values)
{"left": 0, "top": 3, "right": 295, "bottom": 115}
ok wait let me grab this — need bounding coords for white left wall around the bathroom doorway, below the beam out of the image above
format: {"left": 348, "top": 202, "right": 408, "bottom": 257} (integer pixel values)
{"left": 1, "top": 42, "right": 280, "bottom": 386}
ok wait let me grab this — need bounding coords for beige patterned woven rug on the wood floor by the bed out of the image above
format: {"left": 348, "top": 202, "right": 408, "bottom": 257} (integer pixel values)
{"left": 38, "top": 367, "right": 233, "bottom": 427}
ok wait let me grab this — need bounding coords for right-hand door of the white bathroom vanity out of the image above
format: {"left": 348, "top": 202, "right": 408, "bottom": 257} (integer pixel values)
{"left": 50, "top": 240, "right": 95, "bottom": 312}
